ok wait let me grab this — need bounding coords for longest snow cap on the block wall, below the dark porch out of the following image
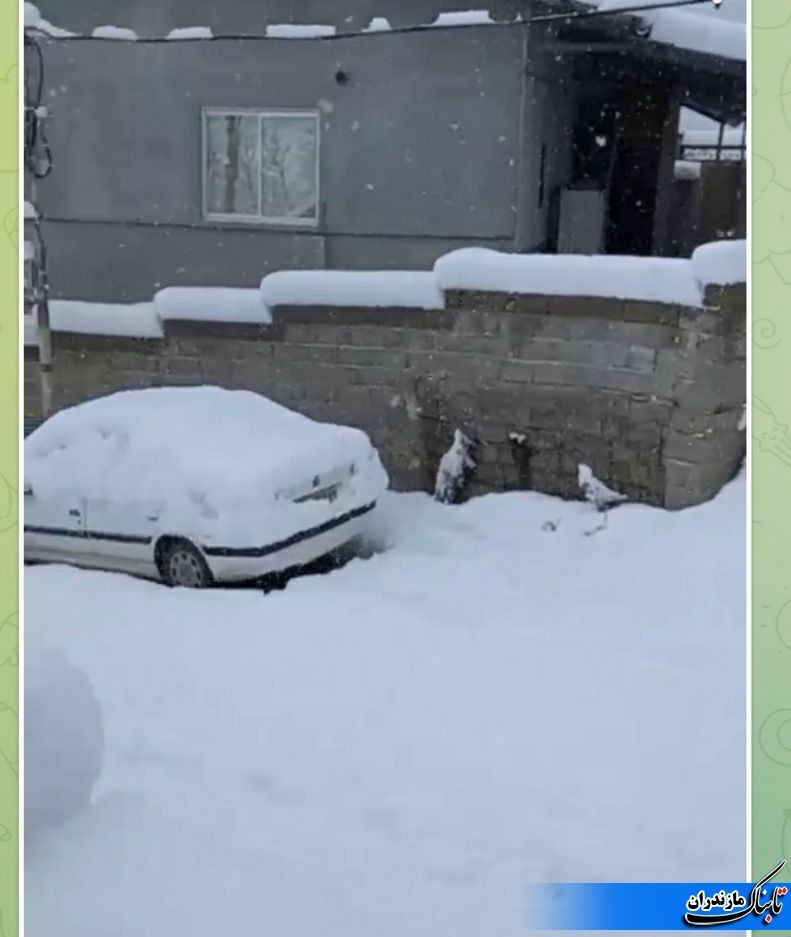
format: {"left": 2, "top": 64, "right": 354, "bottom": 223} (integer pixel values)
{"left": 434, "top": 247, "right": 701, "bottom": 306}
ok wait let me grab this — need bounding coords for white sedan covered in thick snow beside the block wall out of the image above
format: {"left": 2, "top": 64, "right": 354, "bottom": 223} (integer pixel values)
{"left": 24, "top": 387, "right": 388, "bottom": 587}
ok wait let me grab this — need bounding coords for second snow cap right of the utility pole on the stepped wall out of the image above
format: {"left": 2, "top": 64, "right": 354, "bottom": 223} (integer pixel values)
{"left": 154, "top": 286, "right": 272, "bottom": 324}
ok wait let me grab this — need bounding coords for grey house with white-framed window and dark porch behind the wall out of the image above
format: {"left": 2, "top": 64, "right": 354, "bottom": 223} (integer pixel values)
{"left": 23, "top": 0, "right": 746, "bottom": 302}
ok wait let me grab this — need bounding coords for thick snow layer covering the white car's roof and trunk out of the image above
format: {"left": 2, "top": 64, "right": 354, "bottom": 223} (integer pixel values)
{"left": 25, "top": 387, "right": 387, "bottom": 546}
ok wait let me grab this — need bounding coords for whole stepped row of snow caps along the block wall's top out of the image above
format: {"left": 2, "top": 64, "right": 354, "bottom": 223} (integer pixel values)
{"left": 25, "top": 241, "right": 747, "bottom": 344}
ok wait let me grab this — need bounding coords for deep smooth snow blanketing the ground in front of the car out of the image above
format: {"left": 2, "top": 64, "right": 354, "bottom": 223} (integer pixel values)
{"left": 26, "top": 478, "right": 745, "bottom": 937}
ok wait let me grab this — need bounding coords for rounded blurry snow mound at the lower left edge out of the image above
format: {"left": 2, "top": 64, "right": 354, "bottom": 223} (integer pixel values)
{"left": 25, "top": 649, "right": 104, "bottom": 836}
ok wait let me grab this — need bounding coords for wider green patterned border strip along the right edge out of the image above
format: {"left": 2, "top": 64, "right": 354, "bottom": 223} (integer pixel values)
{"left": 751, "top": 0, "right": 791, "bottom": 916}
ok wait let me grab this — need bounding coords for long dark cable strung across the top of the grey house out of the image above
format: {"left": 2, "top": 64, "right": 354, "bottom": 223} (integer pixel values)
{"left": 25, "top": 0, "right": 719, "bottom": 45}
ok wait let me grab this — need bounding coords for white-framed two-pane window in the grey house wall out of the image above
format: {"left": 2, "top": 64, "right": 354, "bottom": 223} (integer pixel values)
{"left": 202, "top": 108, "right": 319, "bottom": 226}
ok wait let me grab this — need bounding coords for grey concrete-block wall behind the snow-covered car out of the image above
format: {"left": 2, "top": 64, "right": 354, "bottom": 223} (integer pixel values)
{"left": 25, "top": 285, "right": 746, "bottom": 508}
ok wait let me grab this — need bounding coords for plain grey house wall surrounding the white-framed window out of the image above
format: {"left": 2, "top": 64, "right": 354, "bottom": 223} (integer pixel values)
{"left": 38, "top": 26, "right": 571, "bottom": 302}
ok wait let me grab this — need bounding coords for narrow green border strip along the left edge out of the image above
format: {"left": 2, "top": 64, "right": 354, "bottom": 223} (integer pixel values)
{"left": 0, "top": 0, "right": 21, "bottom": 937}
